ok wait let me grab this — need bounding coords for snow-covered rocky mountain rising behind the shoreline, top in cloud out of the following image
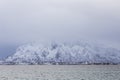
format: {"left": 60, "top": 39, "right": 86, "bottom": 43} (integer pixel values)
{"left": 5, "top": 42, "right": 120, "bottom": 64}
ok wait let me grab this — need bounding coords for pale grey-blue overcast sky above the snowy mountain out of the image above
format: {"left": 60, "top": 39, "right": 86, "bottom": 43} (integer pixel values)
{"left": 0, "top": 0, "right": 120, "bottom": 44}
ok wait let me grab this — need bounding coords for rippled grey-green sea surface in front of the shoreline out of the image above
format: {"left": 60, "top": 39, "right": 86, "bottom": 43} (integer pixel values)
{"left": 0, "top": 65, "right": 120, "bottom": 80}
